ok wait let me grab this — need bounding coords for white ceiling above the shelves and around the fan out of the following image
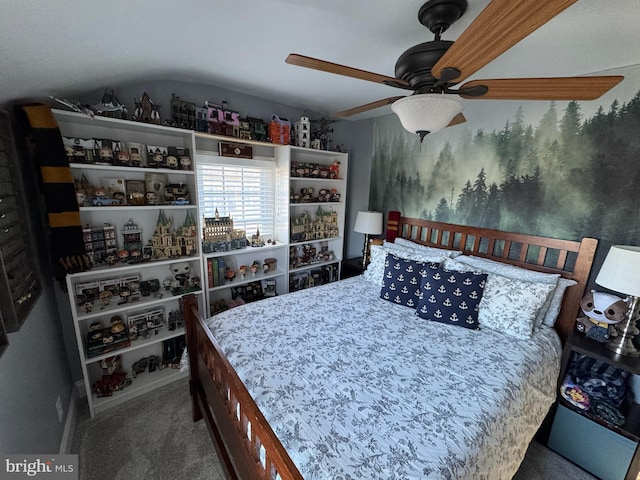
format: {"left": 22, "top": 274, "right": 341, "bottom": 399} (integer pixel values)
{"left": 0, "top": 0, "right": 640, "bottom": 119}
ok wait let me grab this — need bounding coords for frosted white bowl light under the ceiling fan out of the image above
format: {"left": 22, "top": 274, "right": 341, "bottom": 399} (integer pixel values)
{"left": 391, "top": 93, "right": 463, "bottom": 142}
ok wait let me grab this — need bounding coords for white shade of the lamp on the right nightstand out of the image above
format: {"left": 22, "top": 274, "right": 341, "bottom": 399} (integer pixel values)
{"left": 596, "top": 245, "right": 640, "bottom": 297}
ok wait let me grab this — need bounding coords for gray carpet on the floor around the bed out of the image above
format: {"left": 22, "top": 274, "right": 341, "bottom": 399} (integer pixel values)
{"left": 71, "top": 379, "right": 594, "bottom": 480}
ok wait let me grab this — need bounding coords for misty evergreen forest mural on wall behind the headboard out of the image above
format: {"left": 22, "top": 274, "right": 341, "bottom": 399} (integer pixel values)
{"left": 369, "top": 67, "right": 640, "bottom": 278}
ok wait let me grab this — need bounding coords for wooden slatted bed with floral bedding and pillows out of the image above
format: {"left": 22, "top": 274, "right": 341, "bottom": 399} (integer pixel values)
{"left": 184, "top": 212, "right": 597, "bottom": 480}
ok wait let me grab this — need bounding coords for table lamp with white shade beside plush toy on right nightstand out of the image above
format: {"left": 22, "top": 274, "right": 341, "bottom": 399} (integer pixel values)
{"left": 596, "top": 245, "right": 640, "bottom": 357}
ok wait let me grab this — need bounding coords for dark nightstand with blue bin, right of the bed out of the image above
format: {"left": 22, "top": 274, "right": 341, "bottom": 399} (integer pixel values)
{"left": 547, "top": 332, "right": 640, "bottom": 480}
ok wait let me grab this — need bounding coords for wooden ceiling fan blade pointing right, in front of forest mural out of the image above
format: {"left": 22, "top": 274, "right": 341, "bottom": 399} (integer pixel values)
{"left": 459, "top": 75, "right": 624, "bottom": 100}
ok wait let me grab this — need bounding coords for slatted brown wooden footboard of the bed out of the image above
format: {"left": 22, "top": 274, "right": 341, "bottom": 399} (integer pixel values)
{"left": 183, "top": 295, "right": 302, "bottom": 480}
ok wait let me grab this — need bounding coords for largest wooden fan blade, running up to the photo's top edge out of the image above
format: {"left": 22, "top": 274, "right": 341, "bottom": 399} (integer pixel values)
{"left": 431, "top": 0, "right": 577, "bottom": 83}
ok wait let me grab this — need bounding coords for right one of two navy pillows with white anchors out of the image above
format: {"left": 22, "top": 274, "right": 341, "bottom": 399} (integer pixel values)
{"left": 416, "top": 267, "right": 487, "bottom": 330}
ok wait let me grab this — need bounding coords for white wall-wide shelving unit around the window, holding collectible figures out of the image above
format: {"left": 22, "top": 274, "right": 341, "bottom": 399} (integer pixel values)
{"left": 54, "top": 111, "right": 348, "bottom": 416}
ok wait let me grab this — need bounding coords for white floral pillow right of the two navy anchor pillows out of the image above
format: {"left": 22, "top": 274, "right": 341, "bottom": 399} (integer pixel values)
{"left": 478, "top": 274, "right": 555, "bottom": 338}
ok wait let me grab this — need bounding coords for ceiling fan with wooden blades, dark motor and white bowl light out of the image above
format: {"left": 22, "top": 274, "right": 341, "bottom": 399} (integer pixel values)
{"left": 286, "top": 0, "right": 624, "bottom": 142}
